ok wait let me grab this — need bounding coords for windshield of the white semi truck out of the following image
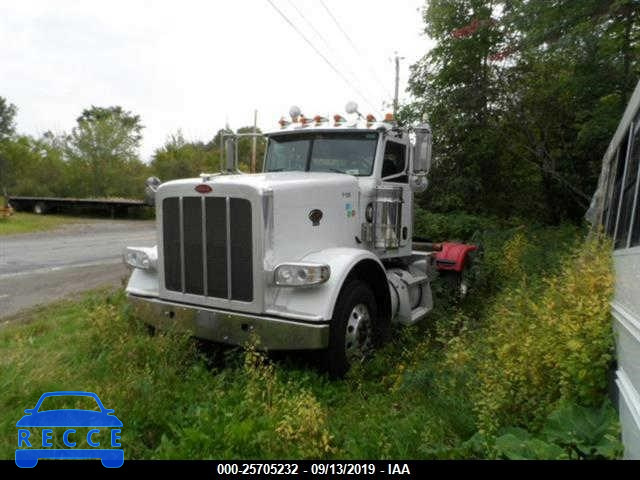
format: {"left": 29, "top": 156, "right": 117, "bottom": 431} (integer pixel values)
{"left": 265, "top": 132, "right": 378, "bottom": 176}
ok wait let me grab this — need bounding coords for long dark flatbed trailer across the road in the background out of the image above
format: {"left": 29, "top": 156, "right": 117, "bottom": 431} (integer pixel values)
{"left": 7, "top": 196, "right": 147, "bottom": 217}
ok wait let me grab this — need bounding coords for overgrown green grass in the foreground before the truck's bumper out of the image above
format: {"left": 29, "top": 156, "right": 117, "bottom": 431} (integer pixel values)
{"left": 0, "top": 286, "right": 473, "bottom": 458}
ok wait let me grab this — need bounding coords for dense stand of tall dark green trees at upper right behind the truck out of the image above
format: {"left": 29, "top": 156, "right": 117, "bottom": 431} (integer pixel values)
{"left": 402, "top": 0, "right": 640, "bottom": 223}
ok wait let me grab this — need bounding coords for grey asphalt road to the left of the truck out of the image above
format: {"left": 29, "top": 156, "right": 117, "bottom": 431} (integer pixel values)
{"left": 0, "top": 220, "right": 156, "bottom": 319}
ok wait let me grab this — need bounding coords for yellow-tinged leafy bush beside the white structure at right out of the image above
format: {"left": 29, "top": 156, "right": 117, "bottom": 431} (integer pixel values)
{"left": 474, "top": 232, "right": 613, "bottom": 432}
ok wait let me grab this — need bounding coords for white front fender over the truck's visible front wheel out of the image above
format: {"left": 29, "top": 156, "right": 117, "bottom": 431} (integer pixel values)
{"left": 266, "top": 248, "right": 385, "bottom": 321}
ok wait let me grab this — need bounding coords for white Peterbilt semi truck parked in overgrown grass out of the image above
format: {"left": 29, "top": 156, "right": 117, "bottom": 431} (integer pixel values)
{"left": 124, "top": 103, "right": 475, "bottom": 376}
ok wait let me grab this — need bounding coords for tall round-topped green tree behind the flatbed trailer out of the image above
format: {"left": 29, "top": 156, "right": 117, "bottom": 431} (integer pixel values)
{"left": 66, "top": 106, "right": 147, "bottom": 197}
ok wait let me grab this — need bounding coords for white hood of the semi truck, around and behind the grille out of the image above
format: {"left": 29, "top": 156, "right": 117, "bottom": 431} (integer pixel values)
{"left": 156, "top": 172, "right": 362, "bottom": 300}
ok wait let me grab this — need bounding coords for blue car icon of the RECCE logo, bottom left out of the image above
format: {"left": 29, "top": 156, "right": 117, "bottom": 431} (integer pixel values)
{"left": 16, "top": 391, "right": 124, "bottom": 468}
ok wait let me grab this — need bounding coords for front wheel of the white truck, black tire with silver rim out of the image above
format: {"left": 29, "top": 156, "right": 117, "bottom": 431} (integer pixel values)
{"left": 325, "top": 280, "right": 388, "bottom": 378}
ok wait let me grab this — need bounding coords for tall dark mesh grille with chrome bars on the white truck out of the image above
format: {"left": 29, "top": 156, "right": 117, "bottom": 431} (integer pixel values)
{"left": 162, "top": 197, "right": 253, "bottom": 302}
